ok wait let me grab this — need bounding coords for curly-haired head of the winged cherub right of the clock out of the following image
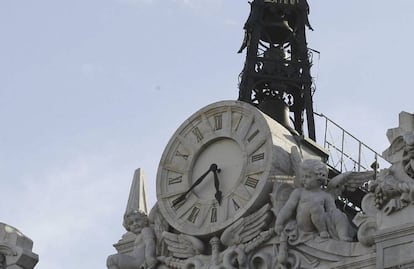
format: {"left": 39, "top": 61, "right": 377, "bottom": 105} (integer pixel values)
{"left": 300, "top": 159, "right": 328, "bottom": 190}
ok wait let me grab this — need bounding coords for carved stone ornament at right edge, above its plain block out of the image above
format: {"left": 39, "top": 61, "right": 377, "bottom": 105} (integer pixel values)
{"left": 354, "top": 112, "right": 414, "bottom": 251}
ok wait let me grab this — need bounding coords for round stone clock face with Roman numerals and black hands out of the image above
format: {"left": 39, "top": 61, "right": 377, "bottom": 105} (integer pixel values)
{"left": 157, "top": 101, "right": 272, "bottom": 235}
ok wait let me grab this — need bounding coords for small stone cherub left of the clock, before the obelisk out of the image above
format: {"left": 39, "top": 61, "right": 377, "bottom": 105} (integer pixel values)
{"left": 106, "top": 210, "right": 157, "bottom": 269}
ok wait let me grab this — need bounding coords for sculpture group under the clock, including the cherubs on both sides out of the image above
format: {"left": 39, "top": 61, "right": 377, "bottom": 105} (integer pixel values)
{"left": 107, "top": 158, "right": 373, "bottom": 269}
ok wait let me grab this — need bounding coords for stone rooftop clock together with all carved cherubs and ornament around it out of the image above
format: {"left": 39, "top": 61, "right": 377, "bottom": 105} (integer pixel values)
{"left": 107, "top": 108, "right": 414, "bottom": 269}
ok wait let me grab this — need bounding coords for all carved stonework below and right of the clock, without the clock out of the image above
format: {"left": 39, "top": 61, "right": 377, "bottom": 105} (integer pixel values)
{"left": 108, "top": 112, "right": 414, "bottom": 269}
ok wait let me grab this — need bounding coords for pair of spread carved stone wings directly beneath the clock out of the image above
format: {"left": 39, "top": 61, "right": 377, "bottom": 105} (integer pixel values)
{"left": 159, "top": 204, "right": 273, "bottom": 269}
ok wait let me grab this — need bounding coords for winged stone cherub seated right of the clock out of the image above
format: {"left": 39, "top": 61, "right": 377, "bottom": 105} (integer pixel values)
{"left": 275, "top": 148, "right": 374, "bottom": 241}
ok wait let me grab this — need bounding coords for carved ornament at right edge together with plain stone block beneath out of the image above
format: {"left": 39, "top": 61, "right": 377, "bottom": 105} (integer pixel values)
{"left": 348, "top": 112, "right": 414, "bottom": 268}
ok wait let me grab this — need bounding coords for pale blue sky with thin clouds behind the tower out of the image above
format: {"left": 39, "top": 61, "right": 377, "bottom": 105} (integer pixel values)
{"left": 0, "top": 0, "right": 414, "bottom": 269}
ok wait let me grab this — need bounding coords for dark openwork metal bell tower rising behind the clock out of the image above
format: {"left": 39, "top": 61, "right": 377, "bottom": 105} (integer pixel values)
{"left": 238, "top": 0, "right": 315, "bottom": 140}
